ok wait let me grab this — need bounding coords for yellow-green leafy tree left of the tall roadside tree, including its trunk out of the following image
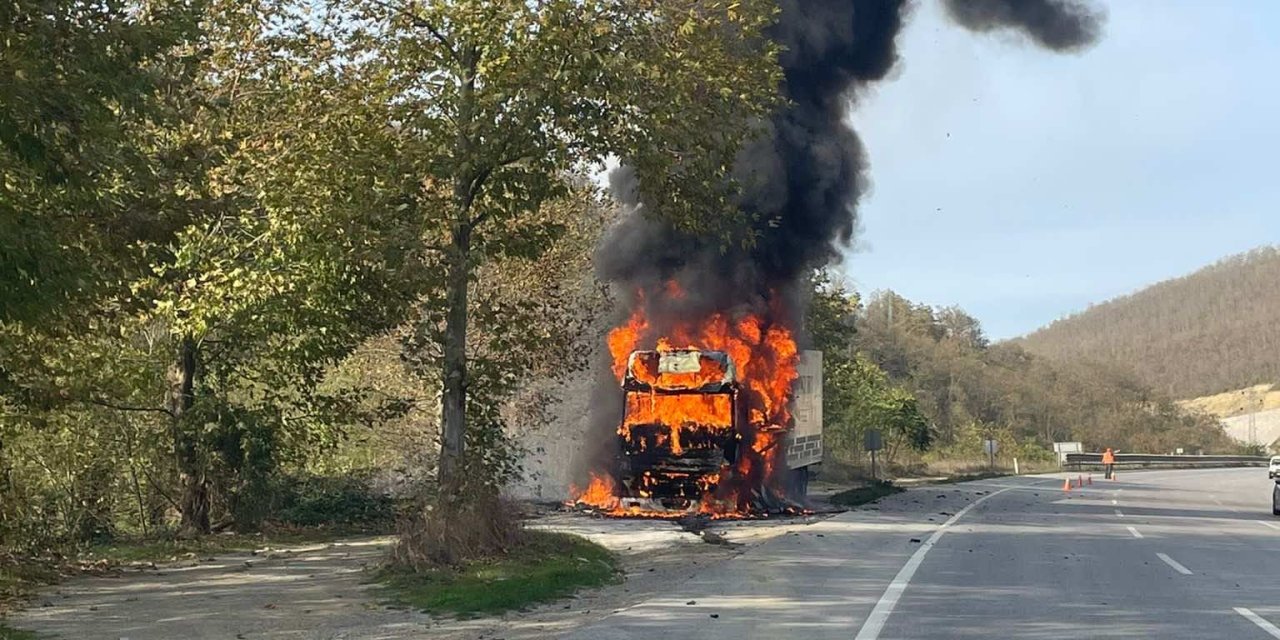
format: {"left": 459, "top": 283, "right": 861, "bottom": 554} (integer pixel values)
{"left": 4, "top": 3, "right": 437, "bottom": 535}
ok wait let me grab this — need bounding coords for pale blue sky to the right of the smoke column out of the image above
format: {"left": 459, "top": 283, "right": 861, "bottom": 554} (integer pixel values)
{"left": 844, "top": 0, "right": 1280, "bottom": 338}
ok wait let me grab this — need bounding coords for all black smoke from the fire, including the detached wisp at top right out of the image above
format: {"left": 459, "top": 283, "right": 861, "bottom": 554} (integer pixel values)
{"left": 588, "top": 0, "right": 1100, "bottom": 494}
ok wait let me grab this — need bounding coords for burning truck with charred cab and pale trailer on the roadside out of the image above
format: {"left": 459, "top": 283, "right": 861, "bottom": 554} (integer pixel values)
{"left": 577, "top": 332, "right": 822, "bottom": 517}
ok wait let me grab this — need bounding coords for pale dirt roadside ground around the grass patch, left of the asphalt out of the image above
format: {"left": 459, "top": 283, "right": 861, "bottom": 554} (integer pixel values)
{"left": 0, "top": 512, "right": 824, "bottom": 640}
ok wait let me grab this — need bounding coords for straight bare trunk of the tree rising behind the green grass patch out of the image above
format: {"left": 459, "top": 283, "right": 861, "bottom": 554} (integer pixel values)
{"left": 439, "top": 224, "right": 471, "bottom": 490}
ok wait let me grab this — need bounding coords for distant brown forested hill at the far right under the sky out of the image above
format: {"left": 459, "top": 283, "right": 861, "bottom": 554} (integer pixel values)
{"left": 1019, "top": 247, "right": 1280, "bottom": 398}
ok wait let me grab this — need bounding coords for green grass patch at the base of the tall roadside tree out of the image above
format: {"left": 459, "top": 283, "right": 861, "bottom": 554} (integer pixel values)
{"left": 378, "top": 531, "right": 617, "bottom": 617}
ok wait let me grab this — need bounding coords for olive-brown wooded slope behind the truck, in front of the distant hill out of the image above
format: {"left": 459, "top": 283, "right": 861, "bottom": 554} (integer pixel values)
{"left": 858, "top": 292, "right": 1233, "bottom": 460}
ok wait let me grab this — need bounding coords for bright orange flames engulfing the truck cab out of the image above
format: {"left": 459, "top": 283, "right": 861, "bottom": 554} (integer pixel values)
{"left": 577, "top": 282, "right": 799, "bottom": 517}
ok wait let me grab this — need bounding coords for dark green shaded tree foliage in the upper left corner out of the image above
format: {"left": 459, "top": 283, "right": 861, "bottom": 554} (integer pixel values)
{"left": 0, "top": 0, "right": 198, "bottom": 323}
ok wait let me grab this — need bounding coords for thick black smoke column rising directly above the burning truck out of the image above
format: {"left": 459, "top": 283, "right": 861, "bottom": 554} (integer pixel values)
{"left": 595, "top": 0, "right": 906, "bottom": 325}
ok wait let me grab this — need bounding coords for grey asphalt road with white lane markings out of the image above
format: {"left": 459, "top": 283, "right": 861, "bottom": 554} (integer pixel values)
{"left": 564, "top": 468, "right": 1280, "bottom": 640}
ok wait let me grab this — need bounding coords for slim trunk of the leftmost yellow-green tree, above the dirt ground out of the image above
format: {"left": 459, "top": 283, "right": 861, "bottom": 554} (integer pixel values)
{"left": 169, "top": 335, "right": 211, "bottom": 536}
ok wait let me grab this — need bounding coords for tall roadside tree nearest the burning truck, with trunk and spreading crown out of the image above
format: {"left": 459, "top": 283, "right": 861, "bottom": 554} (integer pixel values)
{"left": 316, "top": 0, "right": 777, "bottom": 486}
